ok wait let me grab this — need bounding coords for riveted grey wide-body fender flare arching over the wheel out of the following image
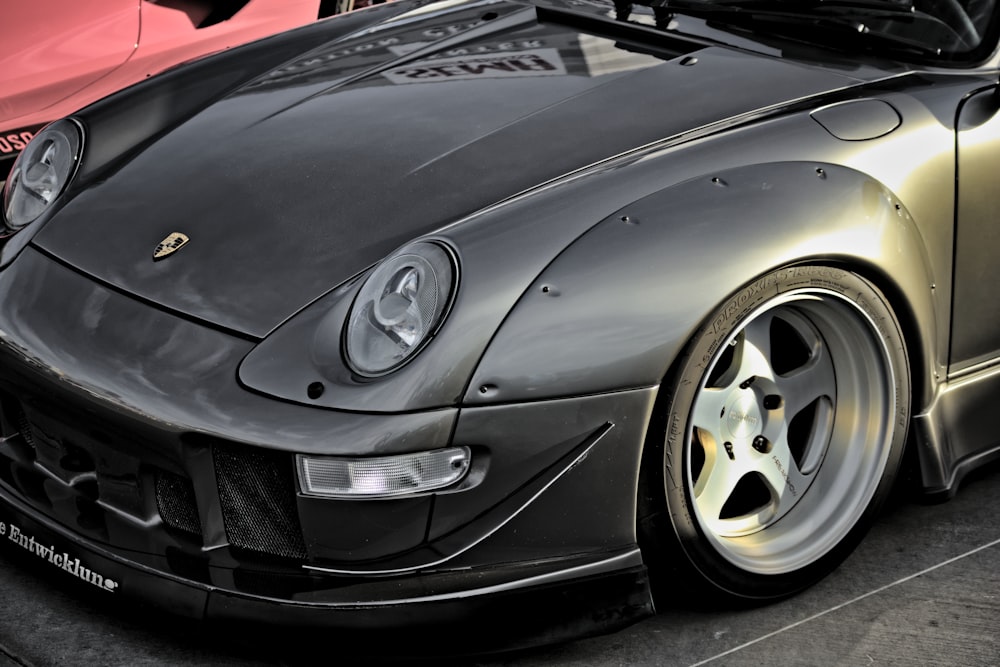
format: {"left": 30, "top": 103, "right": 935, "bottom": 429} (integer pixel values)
{"left": 465, "top": 161, "right": 935, "bottom": 412}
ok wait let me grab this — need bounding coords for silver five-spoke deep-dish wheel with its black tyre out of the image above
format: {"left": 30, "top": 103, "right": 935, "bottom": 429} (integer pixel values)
{"left": 640, "top": 266, "right": 910, "bottom": 600}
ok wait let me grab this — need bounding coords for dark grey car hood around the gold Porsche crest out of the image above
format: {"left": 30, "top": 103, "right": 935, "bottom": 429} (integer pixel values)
{"left": 33, "top": 3, "right": 876, "bottom": 337}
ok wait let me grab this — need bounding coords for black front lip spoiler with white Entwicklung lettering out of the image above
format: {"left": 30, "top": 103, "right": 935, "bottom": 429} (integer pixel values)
{"left": 0, "top": 486, "right": 653, "bottom": 652}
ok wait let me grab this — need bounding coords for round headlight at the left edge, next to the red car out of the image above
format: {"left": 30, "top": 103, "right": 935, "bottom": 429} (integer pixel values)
{"left": 3, "top": 119, "right": 83, "bottom": 232}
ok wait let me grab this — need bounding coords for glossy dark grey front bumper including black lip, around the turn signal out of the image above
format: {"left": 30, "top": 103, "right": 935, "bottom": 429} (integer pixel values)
{"left": 0, "top": 248, "right": 655, "bottom": 644}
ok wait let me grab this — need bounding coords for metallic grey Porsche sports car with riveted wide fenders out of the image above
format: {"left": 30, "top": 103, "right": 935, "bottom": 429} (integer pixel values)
{"left": 0, "top": 0, "right": 1000, "bottom": 641}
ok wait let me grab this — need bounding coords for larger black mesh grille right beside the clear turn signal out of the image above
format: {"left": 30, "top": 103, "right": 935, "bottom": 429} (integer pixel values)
{"left": 212, "top": 444, "right": 306, "bottom": 559}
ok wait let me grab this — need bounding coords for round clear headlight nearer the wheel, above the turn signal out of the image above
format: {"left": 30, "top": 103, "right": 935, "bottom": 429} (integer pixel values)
{"left": 344, "top": 242, "right": 457, "bottom": 377}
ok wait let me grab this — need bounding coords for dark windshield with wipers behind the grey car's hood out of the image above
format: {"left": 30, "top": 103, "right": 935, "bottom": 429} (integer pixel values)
{"left": 596, "top": 0, "right": 997, "bottom": 63}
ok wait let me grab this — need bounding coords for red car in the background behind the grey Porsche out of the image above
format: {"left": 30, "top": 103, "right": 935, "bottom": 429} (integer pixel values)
{"left": 0, "top": 0, "right": 348, "bottom": 175}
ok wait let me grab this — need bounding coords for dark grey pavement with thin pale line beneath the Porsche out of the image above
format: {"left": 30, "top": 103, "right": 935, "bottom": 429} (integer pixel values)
{"left": 0, "top": 465, "right": 1000, "bottom": 667}
